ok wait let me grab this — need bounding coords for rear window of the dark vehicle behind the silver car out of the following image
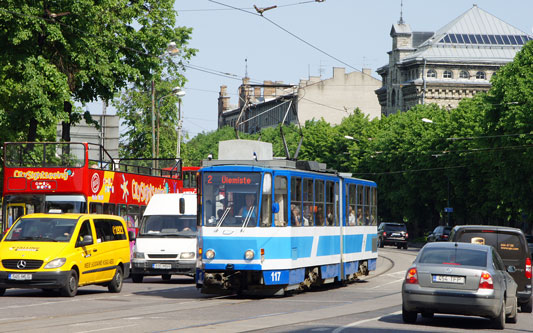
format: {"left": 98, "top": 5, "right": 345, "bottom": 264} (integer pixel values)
{"left": 456, "top": 230, "right": 525, "bottom": 260}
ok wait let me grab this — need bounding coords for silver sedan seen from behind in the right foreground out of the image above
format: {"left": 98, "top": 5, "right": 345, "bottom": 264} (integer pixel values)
{"left": 402, "top": 242, "right": 517, "bottom": 329}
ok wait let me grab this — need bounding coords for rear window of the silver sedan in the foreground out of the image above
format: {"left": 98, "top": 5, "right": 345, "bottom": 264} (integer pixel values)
{"left": 418, "top": 247, "right": 487, "bottom": 267}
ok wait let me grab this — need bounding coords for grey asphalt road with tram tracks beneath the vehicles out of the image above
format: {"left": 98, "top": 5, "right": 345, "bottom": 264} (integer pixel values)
{"left": 0, "top": 247, "right": 533, "bottom": 333}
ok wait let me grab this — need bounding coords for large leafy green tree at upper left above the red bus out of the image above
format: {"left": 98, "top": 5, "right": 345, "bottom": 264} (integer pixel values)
{"left": 0, "top": 0, "right": 194, "bottom": 145}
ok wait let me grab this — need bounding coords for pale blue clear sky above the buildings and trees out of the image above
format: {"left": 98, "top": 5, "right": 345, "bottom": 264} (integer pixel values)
{"left": 91, "top": 0, "right": 533, "bottom": 137}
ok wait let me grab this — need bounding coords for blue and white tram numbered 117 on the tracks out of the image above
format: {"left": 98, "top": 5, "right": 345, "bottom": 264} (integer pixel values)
{"left": 196, "top": 160, "right": 378, "bottom": 294}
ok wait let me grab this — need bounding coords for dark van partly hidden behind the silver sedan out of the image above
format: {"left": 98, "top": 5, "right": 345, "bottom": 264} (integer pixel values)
{"left": 450, "top": 225, "right": 533, "bottom": 313}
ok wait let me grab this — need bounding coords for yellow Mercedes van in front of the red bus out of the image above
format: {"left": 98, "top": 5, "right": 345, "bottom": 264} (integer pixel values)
{"left": 0, "top": 214, "right": 134, "bottom": 297}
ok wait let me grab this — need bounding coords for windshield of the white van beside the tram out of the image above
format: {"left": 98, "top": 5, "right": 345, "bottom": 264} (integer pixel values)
{"left": 137, "top": 215, "right": 196, "bottom": 237}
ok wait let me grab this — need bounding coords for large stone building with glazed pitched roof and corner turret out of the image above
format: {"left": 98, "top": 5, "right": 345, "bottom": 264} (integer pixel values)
{"left": 375, "top": 5, "right": 533, "bottom": 116}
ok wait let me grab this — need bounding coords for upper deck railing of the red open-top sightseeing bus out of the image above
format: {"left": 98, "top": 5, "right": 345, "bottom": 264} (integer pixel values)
{"left": 4, "top": 142, "right": 182, "bottom": 178}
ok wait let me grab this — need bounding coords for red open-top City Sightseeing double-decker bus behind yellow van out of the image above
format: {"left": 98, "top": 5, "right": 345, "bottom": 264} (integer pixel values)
{"left": 1, "top": 142, "right": 198, "bottom": 231}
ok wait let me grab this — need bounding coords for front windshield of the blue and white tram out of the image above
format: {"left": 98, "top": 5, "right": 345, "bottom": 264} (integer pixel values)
{"left": 202, "top": 172, "right": 261, "bottom": 227}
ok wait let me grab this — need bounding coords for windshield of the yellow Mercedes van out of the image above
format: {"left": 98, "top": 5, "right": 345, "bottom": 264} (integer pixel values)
{"left": 5, "top": 218, "right": 77, "bottom": 242}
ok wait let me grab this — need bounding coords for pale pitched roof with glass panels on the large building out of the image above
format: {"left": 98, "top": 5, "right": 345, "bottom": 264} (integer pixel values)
{"left": 402, "top": 5, "right": 533, "bottom": 64}
